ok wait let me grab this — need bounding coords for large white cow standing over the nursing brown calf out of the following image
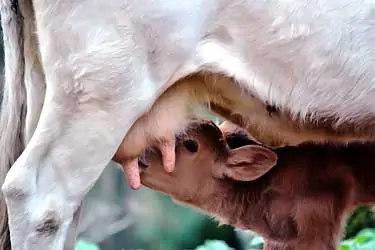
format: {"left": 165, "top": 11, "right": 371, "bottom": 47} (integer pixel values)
{"left": 0, "top": 0, "right": 375, "bottom": 250}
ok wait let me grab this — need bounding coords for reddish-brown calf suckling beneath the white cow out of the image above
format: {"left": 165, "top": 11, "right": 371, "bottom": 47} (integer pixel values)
{"left": 141, "top": 120, "right": 375, "bottom": 250}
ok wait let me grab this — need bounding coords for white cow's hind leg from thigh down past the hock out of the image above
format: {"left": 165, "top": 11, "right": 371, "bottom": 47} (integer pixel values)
{"left": 2, "top": 31, "right": 160, "bottom": 250}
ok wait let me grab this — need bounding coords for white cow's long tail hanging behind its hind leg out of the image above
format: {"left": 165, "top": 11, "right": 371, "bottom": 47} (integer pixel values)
{"left": 0, "top": 0, "right": 26, "bottom": 250}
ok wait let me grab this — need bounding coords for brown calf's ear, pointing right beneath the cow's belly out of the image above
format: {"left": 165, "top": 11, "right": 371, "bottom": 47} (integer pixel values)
{"left": 224, "top": 145, "right": 277, "bottom": 181}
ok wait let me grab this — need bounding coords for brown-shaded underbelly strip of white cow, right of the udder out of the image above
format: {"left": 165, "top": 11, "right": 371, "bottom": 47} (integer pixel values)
{"left": 194, "top": 75, "right": 375, "bottom": 147}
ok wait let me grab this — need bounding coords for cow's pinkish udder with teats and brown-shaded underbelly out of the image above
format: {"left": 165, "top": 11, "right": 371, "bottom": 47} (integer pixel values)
{"left": 113, "top": 73, "right": 374, "bottom": 189}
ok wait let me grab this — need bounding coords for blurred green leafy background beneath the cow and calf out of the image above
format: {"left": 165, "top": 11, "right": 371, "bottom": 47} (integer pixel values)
{"left": 0, "top": 17, "right": 375, "bottom": 250}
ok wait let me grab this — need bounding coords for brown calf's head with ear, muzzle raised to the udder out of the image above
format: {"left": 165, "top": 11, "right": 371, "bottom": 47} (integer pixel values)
{"left": 141, "top": 119, "right": 277, "bottom": 208}
